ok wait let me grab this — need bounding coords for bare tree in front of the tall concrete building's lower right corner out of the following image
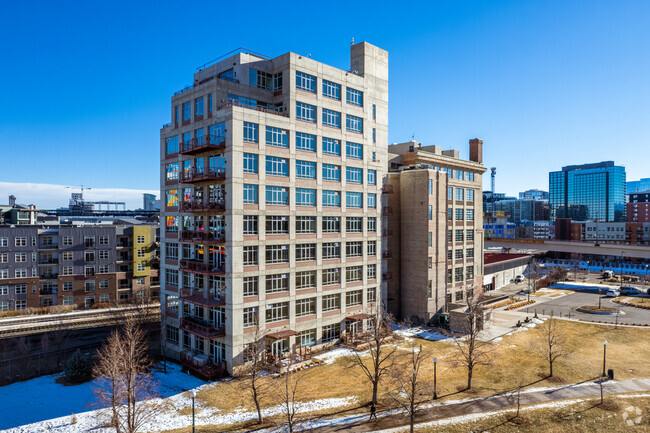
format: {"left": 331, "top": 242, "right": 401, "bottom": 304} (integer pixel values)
{"left": 350, "top": 308, "right": 397, "bottom": 404}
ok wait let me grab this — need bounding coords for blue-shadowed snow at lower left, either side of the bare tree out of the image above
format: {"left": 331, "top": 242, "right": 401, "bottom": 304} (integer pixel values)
{"left": 0, "top": 363, "right": 205, "bottom": 429}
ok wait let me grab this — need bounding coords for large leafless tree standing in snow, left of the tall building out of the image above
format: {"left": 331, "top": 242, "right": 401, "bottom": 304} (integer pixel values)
{"left": 94, "top": 318, "right": 161, "bottom": 433}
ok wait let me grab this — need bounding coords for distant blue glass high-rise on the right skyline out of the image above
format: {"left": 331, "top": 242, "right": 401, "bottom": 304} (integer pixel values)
{"left": 549, "top": 161, "right": 626, "bottom": 221}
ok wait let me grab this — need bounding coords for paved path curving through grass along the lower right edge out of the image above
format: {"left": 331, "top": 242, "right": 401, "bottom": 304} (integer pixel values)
{"left": 307, "top": 379, "right": 650, "bottom": 433}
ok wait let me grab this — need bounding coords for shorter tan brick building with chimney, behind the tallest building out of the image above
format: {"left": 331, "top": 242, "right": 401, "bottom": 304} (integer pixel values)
{"left": 382, "top": 139, "right": 485, "bottom": 323}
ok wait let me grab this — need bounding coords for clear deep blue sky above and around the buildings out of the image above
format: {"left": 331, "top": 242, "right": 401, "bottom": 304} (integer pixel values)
{"left": 0, "top": 0, "right": 650, "bottom": 207}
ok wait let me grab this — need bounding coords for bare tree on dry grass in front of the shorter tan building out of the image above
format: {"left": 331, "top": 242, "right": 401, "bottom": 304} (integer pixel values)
{"left": 453, "top": 287, "right": 492, "bottom": 390}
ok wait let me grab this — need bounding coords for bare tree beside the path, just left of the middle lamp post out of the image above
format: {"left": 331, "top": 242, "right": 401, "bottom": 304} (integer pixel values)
{"left": 389, "top": 344, "right": 429, "bottom": 433}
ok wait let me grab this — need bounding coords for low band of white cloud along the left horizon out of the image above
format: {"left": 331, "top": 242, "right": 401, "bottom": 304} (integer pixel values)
{"left": 0, "top": 182, "right": 160, "bottom": 209}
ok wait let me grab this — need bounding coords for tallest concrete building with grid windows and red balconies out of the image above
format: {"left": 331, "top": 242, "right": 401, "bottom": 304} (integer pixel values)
{"left": 161, "top": 42, "right": 388, "bottom": 375}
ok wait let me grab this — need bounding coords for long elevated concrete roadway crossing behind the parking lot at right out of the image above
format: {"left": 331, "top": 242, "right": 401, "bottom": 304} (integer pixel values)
{"left": 485, "top": 238, "right": 650, "bottom": 260}
